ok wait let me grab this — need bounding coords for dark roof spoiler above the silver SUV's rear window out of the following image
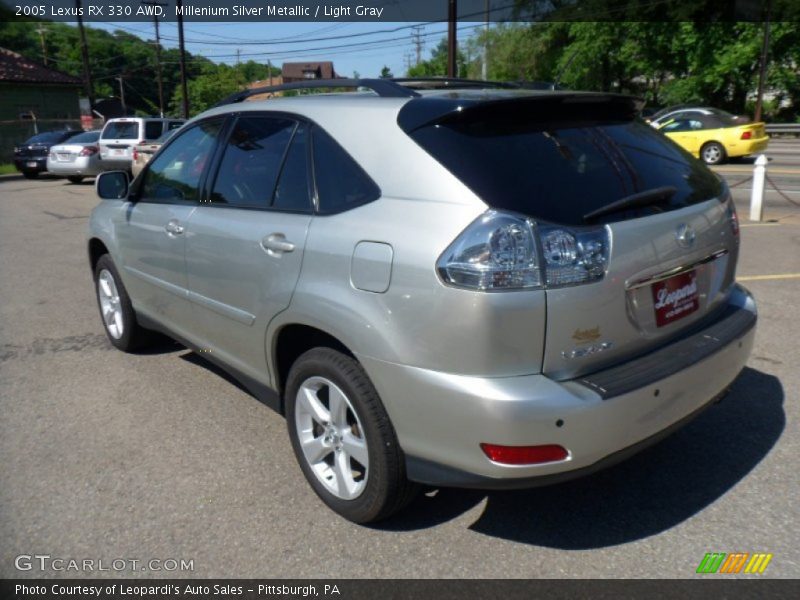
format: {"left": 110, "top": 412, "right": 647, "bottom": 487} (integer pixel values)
{"left": 397, "top": 91, "right": 644, "bottom": 133}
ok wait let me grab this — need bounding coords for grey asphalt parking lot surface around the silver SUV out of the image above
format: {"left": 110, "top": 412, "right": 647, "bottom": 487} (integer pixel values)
{"left": 0, "top": 143, "right": 800, "bottom": 578}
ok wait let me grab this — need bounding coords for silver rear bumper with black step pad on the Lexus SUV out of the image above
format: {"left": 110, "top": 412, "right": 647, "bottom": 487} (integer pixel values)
{"left": 359, "top": 286, "right": 756, "bottom": 488}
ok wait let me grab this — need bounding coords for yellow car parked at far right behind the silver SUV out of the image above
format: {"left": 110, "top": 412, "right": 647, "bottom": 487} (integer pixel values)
{"left": 650, "top": 108, "right": 769, "bottom": 165}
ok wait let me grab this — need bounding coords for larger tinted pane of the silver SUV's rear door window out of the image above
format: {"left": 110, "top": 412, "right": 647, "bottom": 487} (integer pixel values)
{"left": 211, "top": 117, "right": 296, "bottom": 208}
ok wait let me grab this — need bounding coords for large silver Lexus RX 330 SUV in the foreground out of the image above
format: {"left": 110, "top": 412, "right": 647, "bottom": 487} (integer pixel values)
{"left": 88, "top": 80, "right": 756, "bottom": 523}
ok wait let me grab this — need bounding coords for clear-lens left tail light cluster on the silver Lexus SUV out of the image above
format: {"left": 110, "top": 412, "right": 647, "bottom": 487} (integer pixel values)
{"left": 437, "top": 210, "right": 610, "bottom": 291}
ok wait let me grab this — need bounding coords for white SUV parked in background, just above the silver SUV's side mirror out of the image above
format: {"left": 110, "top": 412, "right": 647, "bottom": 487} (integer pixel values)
{"left": 100, "top": 117, "right": 185, "bottom": 171}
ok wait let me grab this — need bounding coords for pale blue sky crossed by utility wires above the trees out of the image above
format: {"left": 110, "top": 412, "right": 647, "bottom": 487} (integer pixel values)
{"left": 90, "top": 22, "right": 488, "bottom": 77}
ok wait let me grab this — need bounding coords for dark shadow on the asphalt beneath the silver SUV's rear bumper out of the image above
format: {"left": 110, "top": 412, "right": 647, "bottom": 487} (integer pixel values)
{"left": 378, "top": 368, "right": 786, "bottom": 550}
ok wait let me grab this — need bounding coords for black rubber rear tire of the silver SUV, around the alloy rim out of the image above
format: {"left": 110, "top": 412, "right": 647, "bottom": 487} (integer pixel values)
{"left": 285, "top": 348, "right": 419, "bottom": 523}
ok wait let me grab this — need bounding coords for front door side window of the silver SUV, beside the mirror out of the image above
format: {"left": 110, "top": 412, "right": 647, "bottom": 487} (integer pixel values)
{"left": 140, "top": 119, "right": 222, "bottom": 202}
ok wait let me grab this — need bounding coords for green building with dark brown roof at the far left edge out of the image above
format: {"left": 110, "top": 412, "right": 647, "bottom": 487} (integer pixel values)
{"left": 0, "top": 48, "right": 82, "bottom": 162}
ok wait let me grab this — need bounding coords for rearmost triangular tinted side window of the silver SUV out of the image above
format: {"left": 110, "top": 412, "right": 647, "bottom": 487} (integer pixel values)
{"left": 313, "top": 127, "right": 381, "bottom": 214}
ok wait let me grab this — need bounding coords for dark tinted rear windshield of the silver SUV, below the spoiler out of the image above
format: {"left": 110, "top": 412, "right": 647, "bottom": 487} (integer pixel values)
{"left": 410, "top": 102, "right": 722, "bottom": 226}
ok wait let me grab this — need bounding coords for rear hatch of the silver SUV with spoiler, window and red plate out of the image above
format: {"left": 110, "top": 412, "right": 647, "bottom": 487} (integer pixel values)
{"left": 399, "top": 93, "right": 738, "bottom": 379}
